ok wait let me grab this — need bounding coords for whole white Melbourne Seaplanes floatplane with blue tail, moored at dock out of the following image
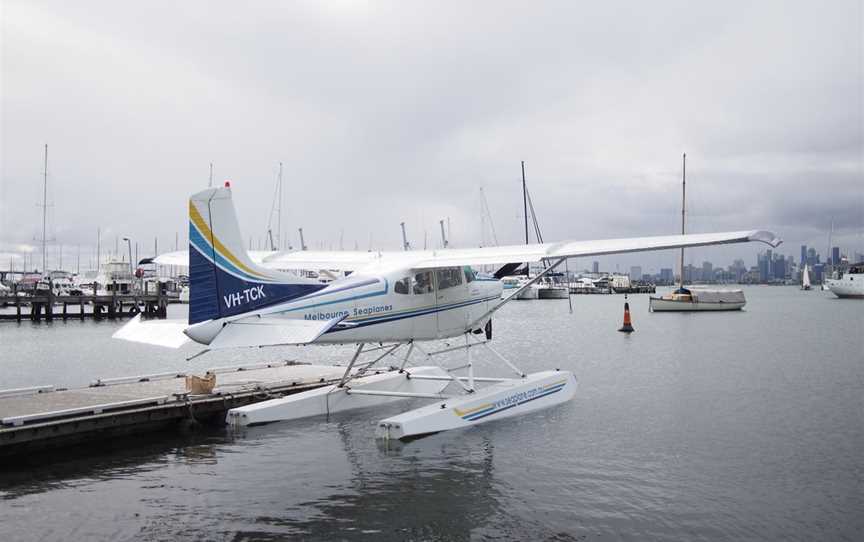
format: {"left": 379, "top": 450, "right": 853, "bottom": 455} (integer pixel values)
{"left": 114, "top": 182, "right": 781, "bottom": 440}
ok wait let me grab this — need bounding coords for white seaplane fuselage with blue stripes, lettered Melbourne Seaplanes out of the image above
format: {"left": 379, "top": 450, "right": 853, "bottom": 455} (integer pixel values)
{"left": 187, "top": 267, "right": 502, "bottom": 344}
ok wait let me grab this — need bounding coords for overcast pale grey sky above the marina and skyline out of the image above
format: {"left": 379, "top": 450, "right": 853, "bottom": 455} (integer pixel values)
{"left": 0, "top": 0, "right": 864, "bottom": 271}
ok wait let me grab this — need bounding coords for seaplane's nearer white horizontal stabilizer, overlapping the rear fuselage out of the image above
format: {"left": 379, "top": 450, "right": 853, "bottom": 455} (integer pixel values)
{"left": 209, "top": 314, "right": 348, "bottom": 350}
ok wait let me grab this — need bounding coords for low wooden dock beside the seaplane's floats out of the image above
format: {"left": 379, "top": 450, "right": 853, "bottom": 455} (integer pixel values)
{"left": 0, "top": 361, "right": 345, "bottom": 457}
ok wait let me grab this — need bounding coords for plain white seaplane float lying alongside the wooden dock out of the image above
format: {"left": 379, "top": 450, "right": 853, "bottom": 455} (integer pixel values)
{"left": 225, "top": 366, "right": 450, "bottom": 426}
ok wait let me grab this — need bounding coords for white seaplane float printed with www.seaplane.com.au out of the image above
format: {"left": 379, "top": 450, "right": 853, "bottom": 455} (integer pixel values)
{"left": 375, "top": 370, "right": 576, "bottom": 440}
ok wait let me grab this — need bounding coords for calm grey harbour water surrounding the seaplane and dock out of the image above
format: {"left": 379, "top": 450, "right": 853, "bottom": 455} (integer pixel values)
{"left": 0, "top": 287, "right": 864, "bottom": 541}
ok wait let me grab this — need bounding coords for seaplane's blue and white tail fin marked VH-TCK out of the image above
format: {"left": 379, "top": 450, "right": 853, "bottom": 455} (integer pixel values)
{"left": 189, "top": 183, "right": 324, "bottom": 324}
